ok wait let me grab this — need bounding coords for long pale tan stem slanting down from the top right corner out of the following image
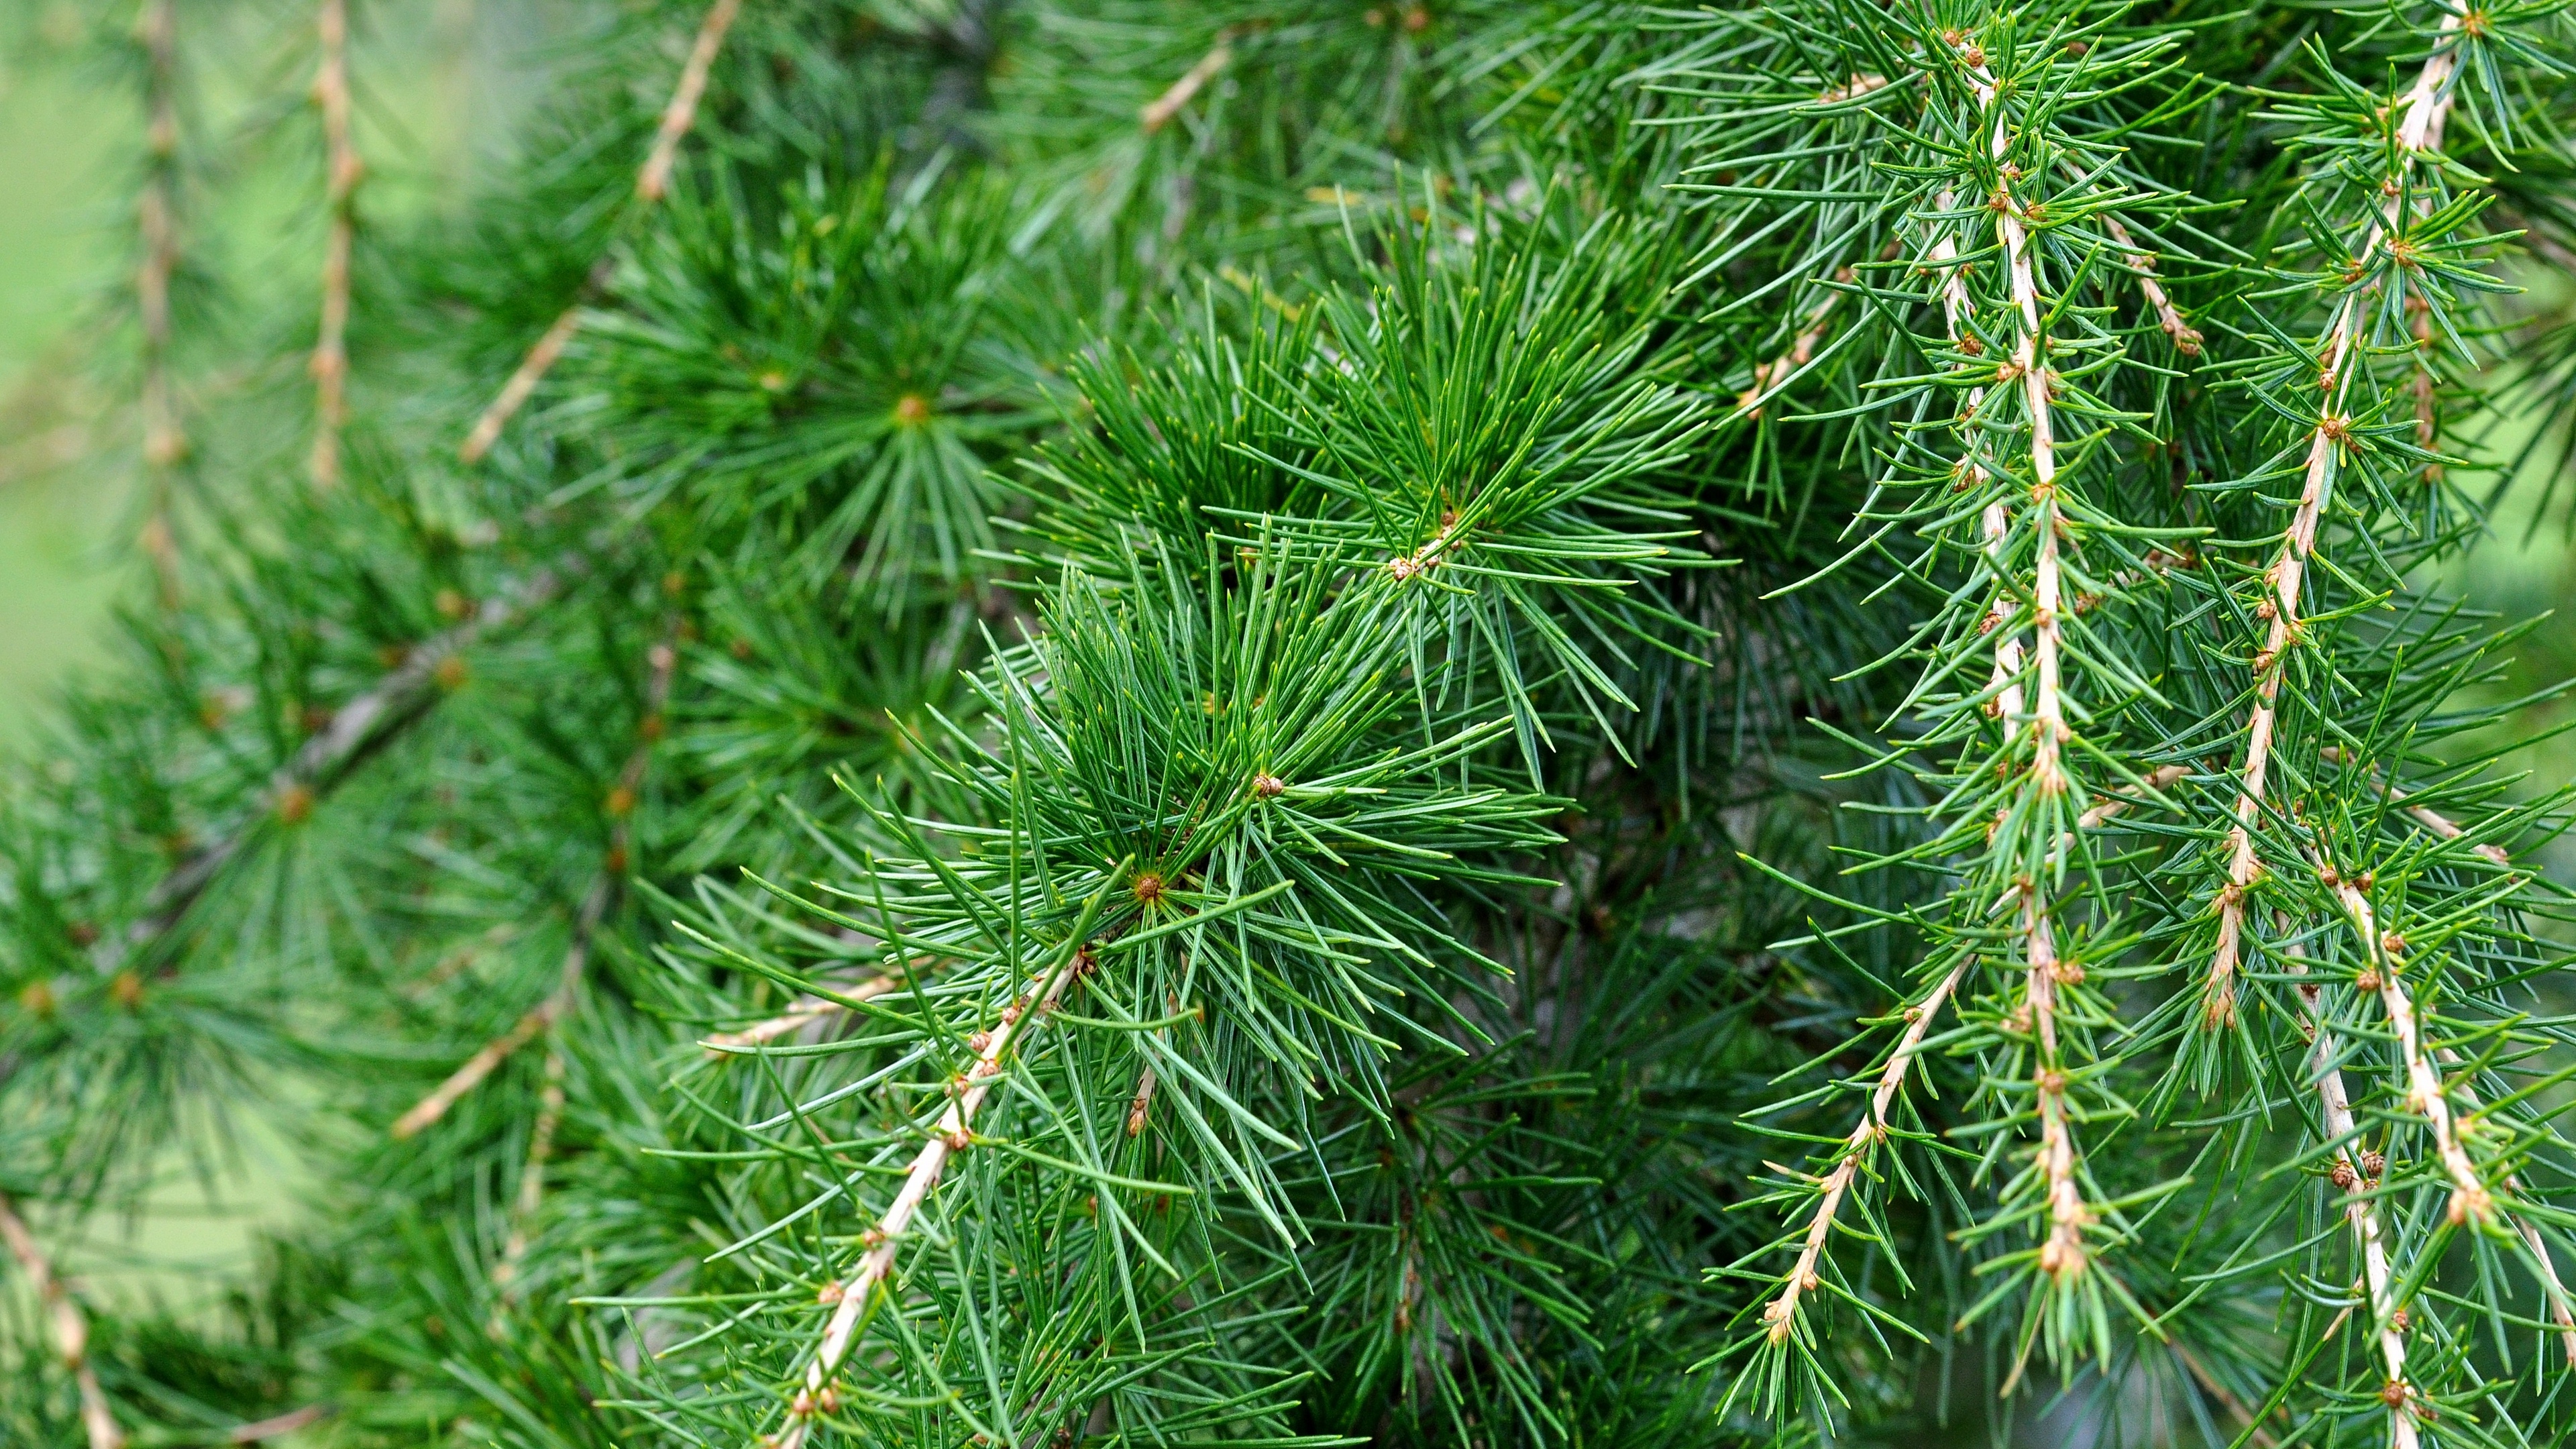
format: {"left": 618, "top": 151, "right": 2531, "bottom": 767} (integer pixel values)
{"left": 2200, "top": 28, "right": 2460, "bottom": 1029}
